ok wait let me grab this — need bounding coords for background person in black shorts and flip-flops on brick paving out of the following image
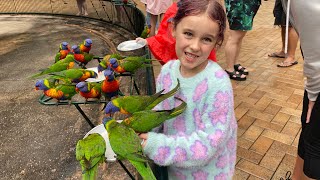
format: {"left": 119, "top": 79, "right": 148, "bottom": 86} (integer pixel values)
{"left": 268, "top": 0, "right": 299, "bottom": 67}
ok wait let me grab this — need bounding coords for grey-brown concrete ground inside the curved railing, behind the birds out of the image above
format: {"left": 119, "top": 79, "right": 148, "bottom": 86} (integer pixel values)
{"left": 0, "top": 15, "right": 153, "bottom": 179}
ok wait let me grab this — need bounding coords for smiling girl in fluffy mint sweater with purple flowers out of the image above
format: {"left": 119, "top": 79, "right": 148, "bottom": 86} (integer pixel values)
{"left": 140, "top": 0, "right": 237, "bottom": 180}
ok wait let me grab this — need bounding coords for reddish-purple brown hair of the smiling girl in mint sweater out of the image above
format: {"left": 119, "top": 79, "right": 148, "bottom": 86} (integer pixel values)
{"left": 173, "top": 0, "right": 226, "bottom": 47}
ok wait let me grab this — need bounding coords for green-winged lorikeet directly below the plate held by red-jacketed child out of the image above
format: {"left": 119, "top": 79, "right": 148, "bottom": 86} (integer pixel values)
{"left": 109, "top": 56, "right": 152, "bottom": 74}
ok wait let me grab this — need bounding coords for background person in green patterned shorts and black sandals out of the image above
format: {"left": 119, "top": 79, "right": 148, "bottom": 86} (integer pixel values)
{"left": 225, "top": 0, "right": 261, "bottom": 81}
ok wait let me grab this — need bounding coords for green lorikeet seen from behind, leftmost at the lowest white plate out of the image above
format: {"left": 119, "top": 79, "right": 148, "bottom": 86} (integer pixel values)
{"left": 76, "top": 134, "right": 106, "bottom": 180}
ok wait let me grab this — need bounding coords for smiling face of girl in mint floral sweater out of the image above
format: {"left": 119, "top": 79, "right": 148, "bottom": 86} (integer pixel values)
{"left": 172, "top": 13, "right": 219, "bottom": 77}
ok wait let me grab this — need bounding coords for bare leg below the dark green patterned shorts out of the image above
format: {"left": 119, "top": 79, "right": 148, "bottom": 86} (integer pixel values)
{"left": 225, "top": 30, "right": 247, "bottom": 78}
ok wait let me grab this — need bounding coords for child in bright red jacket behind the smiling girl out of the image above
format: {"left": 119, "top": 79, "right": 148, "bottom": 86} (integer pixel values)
{"left": 137, "top": 2, "right": 216, "bottom": 65}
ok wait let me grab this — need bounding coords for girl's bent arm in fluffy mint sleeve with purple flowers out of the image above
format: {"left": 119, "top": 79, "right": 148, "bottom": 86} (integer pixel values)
{"left": 142, "top": 73, "right": 237, "bottom": 167}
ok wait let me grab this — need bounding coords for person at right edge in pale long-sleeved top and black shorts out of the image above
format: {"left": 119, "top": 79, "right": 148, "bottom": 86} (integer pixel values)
{"left": 283, "top": 0, "right": 320, "bottom": 180}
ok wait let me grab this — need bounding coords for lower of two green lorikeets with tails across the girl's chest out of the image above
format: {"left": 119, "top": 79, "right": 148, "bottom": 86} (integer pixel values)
{"left": 121, "top": 98, "right": 187, "bottom": 133}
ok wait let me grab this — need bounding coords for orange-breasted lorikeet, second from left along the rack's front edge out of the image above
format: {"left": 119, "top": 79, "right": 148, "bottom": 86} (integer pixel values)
{"left": 76, "top": 81, "right": 101, "bottom": 101}
